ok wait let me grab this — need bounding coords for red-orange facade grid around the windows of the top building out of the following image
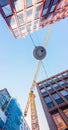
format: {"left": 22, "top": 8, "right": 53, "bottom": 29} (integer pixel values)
{"left": 0, "top": 0, "right": 68, "bottom": 39}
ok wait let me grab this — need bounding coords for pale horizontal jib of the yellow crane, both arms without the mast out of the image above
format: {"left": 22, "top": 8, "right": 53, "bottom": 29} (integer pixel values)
{"left": 24, "top": 24, "right": 52, "bottom": 117}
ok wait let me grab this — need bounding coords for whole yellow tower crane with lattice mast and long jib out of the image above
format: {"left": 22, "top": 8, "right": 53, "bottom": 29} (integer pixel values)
{"left": 24, "top": 25, "right": 52, "bottom": 130}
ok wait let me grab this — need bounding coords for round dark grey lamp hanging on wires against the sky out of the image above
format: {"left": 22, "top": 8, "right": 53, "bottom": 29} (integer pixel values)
{"left": 33, "top": 46, "right": 46, "bottom": 60}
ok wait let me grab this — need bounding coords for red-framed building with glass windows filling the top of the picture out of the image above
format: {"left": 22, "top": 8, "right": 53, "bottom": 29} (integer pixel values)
{"left": 0, "top": 0, "right": 68, "bottom": 38}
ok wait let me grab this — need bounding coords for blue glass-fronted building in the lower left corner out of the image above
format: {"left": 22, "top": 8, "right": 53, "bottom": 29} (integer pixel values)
{"left": 0, "top": 89, "right": 30, "bottom": 130}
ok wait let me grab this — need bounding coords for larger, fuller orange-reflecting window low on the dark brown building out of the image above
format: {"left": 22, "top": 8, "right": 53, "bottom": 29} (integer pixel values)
{"left": 52, "top": 113, "right": 67, "bottom": 130}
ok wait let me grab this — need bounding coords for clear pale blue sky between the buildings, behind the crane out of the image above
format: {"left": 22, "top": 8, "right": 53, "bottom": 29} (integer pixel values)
{"left": 0, "top": 13, "right": 68, "bottom": 130}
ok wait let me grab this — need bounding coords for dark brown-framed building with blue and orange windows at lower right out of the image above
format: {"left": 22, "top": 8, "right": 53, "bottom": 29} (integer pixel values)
{"left": 36, "top": 70, "right": 68, "bottom": 130}
